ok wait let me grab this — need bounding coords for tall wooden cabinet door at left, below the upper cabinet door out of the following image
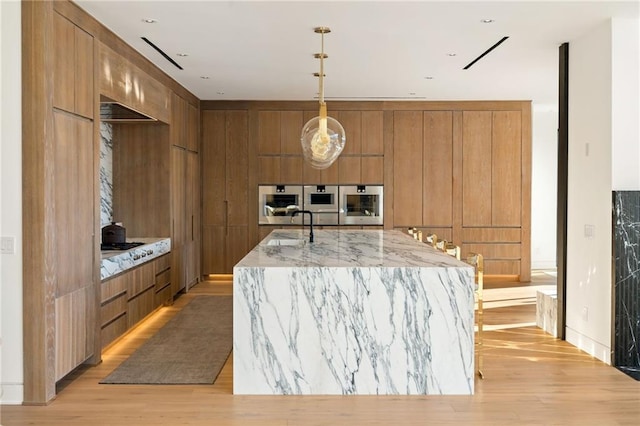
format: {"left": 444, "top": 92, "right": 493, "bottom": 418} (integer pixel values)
{"left": 51, "top": 111, "right": 97, "bottom": 380}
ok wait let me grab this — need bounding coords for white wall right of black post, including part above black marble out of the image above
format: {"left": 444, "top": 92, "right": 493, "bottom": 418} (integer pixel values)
{"left": 566, "top": 19, "right": 640, "bottom": 363}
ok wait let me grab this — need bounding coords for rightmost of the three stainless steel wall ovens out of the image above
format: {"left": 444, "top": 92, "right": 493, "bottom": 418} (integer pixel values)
{"left": 339, "top": 185, "right": 384, "bottom": 225}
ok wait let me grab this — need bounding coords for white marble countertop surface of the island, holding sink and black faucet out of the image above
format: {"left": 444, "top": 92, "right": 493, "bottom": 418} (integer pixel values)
{"left": 236, "top": 229, "right": 469, "bottom": 268}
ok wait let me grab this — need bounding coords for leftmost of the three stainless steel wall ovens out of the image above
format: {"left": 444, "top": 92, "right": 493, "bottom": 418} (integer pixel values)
{"left": 258, "top": 185, "right": 303, "bottom": 225}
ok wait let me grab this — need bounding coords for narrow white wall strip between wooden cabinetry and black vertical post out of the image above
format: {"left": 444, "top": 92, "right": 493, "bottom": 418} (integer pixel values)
{"left": 531, "top": 105, "right": 558, "bottom": 269}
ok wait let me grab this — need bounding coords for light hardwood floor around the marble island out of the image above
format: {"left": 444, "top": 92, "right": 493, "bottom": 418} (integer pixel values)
{"left": 0, "top": 274, "right": 640, "bottom": 426}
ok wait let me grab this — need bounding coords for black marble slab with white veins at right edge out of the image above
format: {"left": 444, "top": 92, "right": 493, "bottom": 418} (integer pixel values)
{"left": 613, "top": 191, "right": 640, "bottom": 380}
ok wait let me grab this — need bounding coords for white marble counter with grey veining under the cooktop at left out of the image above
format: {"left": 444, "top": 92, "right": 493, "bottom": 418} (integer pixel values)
{"left": 100, "top": 238, "right": 171, "bottom": 280}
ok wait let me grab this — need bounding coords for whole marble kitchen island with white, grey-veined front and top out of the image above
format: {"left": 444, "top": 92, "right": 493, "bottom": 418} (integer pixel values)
{"left": 233, "top": 229, "right": 474, "bottom": 395}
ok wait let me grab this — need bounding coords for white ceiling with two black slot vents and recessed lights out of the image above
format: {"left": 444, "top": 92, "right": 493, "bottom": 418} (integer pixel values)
{"left": 75, "top": 0, "right": 640, "bottom": 105}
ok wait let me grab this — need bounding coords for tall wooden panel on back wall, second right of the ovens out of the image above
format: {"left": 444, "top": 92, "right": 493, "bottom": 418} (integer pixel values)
{"left": 422, "top": 111, "right": 453, "bottom": 226}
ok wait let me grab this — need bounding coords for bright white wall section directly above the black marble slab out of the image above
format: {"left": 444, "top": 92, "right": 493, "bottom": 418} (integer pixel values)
{"left": 611, "top": 18, "right": 640, "bottom": 190}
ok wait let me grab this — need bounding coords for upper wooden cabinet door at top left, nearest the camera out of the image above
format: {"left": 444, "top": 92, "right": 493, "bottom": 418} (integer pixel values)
{"left": 53, "top": 12, "right": 95, "bottom": 118}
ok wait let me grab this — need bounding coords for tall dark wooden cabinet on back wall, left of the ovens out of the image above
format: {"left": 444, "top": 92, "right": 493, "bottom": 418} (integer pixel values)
{"left": 202, "top": 110, "right": 248, "bottom": 274}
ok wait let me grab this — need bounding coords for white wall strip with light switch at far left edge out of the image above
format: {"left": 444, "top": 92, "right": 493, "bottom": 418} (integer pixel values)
{"left": 0, "top": 0, "right": 24, "bottom": 404}
